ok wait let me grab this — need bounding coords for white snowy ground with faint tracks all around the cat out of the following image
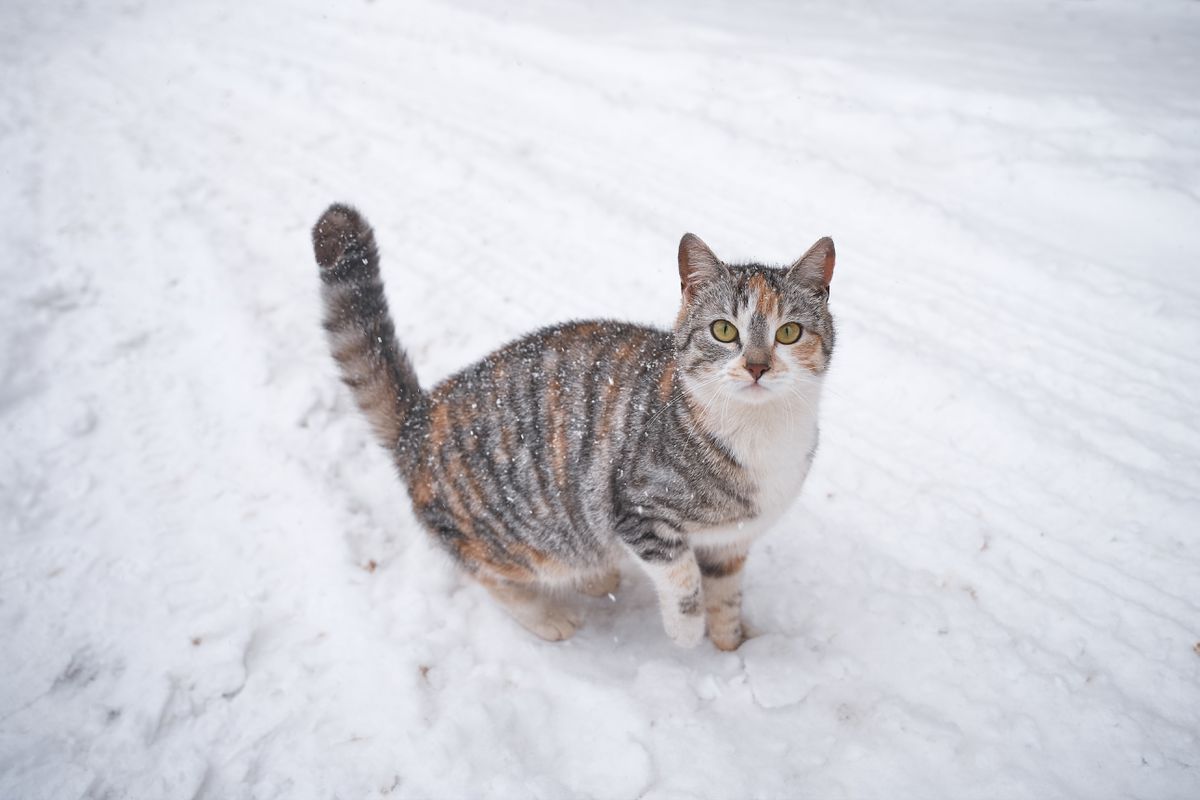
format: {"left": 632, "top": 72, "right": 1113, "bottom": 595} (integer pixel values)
{"left": 0, "top": 0, "right": 1200, "bottom": 800}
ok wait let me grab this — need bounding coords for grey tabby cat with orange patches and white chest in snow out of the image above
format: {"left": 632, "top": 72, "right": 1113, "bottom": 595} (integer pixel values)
{"left": 312, "top": 204, "right": 834, "bottom": 650}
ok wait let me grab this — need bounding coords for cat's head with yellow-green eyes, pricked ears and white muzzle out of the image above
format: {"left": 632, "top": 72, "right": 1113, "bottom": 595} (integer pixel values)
{"left": 674, "top": 234, "right": 834, "bottom": 404}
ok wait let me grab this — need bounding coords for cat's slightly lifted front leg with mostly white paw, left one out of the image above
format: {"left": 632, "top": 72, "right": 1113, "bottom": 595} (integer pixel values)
{"left": 622, "top": 523, "right": 704, "bottom": 648}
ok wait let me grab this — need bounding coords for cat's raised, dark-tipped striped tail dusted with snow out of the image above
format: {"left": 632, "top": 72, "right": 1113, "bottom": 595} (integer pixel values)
{"left": 312, "top": 203, "right": 424, "bottom": 460}
